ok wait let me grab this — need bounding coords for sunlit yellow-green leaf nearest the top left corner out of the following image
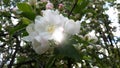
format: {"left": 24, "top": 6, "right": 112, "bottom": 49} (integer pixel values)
{"left": 17, "top": 3, "right": 33, "bottom": 12}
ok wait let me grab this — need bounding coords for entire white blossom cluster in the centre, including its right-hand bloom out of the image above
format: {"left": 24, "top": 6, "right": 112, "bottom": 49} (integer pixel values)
{"left": 23, "top": 9, "right": 80, "bottom": 54}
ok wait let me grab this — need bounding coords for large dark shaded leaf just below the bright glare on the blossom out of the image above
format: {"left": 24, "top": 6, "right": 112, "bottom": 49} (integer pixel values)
{"left": 54, "top": 45, "right": 80, "bottom": 61}
